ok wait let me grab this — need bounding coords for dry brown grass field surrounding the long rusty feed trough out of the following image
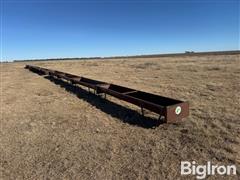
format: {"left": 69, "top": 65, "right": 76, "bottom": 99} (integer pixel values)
{"left": 0, "top": 55, "right": 240, "bottom": 179}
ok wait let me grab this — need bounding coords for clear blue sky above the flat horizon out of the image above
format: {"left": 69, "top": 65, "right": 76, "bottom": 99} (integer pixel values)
{"left": 1, "top": 0, "right": 240, "bottom": 60}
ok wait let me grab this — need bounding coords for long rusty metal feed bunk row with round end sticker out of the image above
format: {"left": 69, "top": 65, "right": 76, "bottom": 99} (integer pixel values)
{"left": 25, "top": 65, "right": 189, "bottom": 123}
